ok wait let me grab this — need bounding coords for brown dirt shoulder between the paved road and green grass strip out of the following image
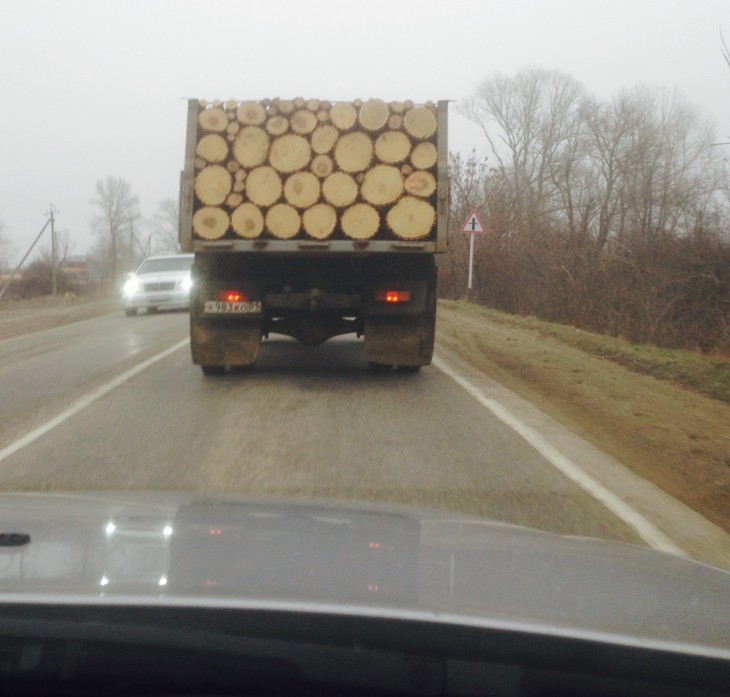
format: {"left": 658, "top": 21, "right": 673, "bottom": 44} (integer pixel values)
{"left": 437, "top": 302, "right": 730, "bottom": 531}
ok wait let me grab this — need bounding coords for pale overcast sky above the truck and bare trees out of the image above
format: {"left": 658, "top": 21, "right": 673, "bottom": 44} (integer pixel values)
{"left": 0, "top": 0, "right": 730, "bottom": 260}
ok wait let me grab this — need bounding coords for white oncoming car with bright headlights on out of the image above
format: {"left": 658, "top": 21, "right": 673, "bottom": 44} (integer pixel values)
{"left": 122, "top": 254, "right": 195, "bottom": 317}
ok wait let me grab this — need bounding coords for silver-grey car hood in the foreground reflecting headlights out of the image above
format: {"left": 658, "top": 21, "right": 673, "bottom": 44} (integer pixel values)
{"left": 0, "top": 493, "right": 730, "bottom": 658}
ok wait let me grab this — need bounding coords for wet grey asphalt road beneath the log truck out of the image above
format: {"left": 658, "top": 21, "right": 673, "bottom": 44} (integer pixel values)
{"left": 0, "top": 313, "right": 730, "bottom": 566}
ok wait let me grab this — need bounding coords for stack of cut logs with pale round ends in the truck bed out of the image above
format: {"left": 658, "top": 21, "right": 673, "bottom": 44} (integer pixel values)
{"left": 193, "top": 98, "right": 438, "bottom": 240}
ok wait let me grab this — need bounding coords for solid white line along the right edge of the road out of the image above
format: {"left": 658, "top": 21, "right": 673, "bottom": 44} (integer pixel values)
{"left": 433, "top": 357, "right": 687, "bottom": 556}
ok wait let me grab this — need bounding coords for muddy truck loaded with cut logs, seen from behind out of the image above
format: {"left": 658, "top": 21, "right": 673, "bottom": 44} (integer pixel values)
{"left": 180, "top": 98, "right": 449, "bottom": 374}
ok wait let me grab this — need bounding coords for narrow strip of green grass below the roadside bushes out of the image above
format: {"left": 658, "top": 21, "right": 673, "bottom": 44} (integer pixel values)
{"left": 441, "top": 300, "right": 730, "bottom": 404}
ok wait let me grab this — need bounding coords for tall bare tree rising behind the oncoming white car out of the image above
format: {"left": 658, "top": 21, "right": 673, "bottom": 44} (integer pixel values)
{"left": 91, "top": 176, "right": 140, "bottom": 282}
